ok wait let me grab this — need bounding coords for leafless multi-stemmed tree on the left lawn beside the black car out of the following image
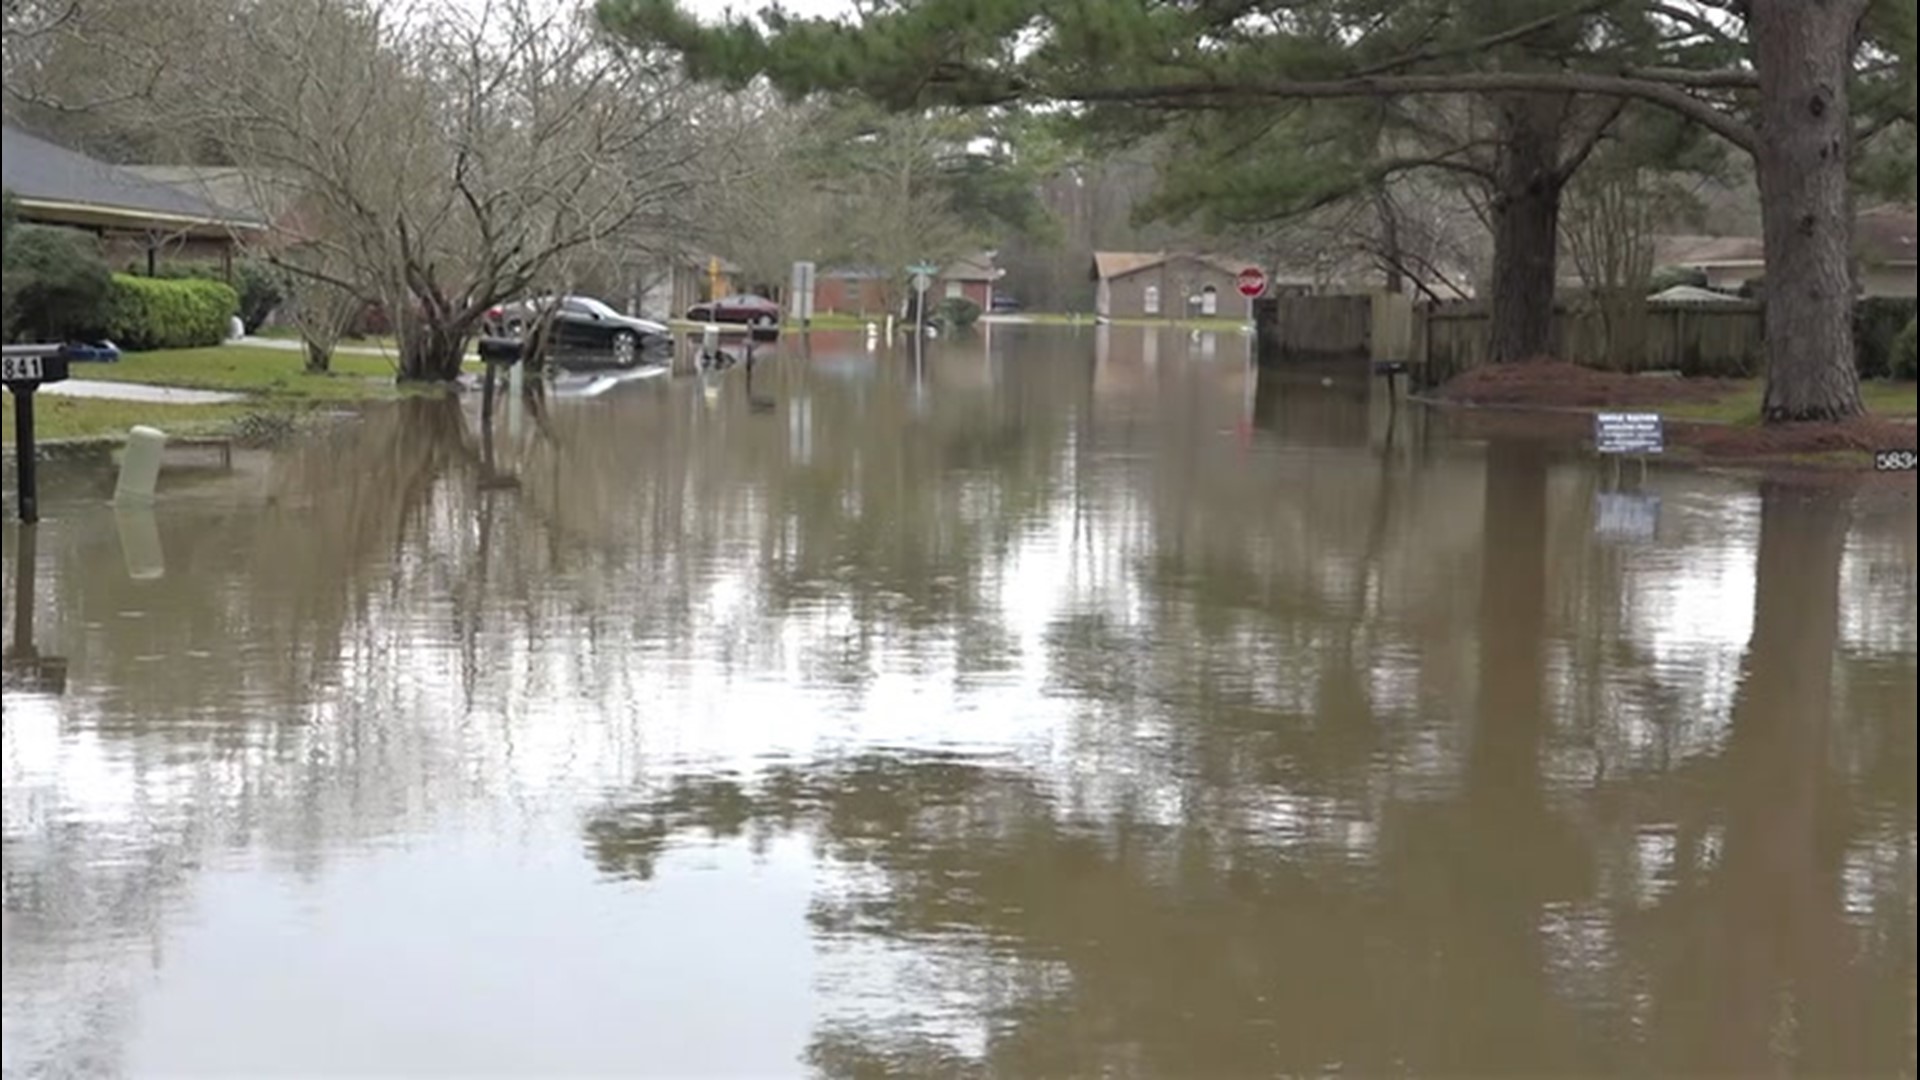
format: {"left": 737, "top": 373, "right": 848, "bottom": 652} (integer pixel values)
{"left": 180, "top": 0, "right": 710, "bottom": 380}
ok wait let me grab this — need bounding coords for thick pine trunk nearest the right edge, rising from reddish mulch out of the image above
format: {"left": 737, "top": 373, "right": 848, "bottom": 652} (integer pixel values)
{"left": 1747, "top": 0, "right": 1866, "bottom": 423}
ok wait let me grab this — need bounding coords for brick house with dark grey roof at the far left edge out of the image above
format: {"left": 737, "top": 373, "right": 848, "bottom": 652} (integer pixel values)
{"left": 0, "top": 125, "right": 267, "bottom": 273}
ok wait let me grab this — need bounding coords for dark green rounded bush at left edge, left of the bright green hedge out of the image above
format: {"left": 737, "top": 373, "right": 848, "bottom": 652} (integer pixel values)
{"left": 0, "top": 225, "right": 113, "bottom": 342}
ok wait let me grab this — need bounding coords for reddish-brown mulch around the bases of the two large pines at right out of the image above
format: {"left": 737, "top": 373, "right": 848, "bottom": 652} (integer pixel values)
{"left": 1434, "top": 359, "right": 1916, "bottom": 467}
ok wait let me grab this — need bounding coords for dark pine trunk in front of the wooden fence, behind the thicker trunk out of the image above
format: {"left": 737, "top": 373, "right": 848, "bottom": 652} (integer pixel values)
{"left": 1490, "top": 94, "right": 1567, "bottom": 363}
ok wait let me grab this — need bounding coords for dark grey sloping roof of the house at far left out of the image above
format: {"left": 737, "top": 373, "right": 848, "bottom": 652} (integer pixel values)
{"left": 0, "top": 125, "right": 265, "bottom": 231}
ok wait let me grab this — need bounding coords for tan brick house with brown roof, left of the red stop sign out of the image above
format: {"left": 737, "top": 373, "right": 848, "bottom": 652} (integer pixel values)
{"left": 1092, "top": 252, "right": 1313, "bottom": 319}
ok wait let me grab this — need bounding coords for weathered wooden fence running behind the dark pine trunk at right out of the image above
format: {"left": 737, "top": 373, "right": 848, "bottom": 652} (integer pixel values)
{"left": 1413, "top": 300, "right": 1763, "bottom": 386}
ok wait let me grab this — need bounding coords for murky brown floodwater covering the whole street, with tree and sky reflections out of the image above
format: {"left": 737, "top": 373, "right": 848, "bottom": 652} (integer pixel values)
{"left": 0, "top": 327, "right": 1916, "bottom": 1078}
